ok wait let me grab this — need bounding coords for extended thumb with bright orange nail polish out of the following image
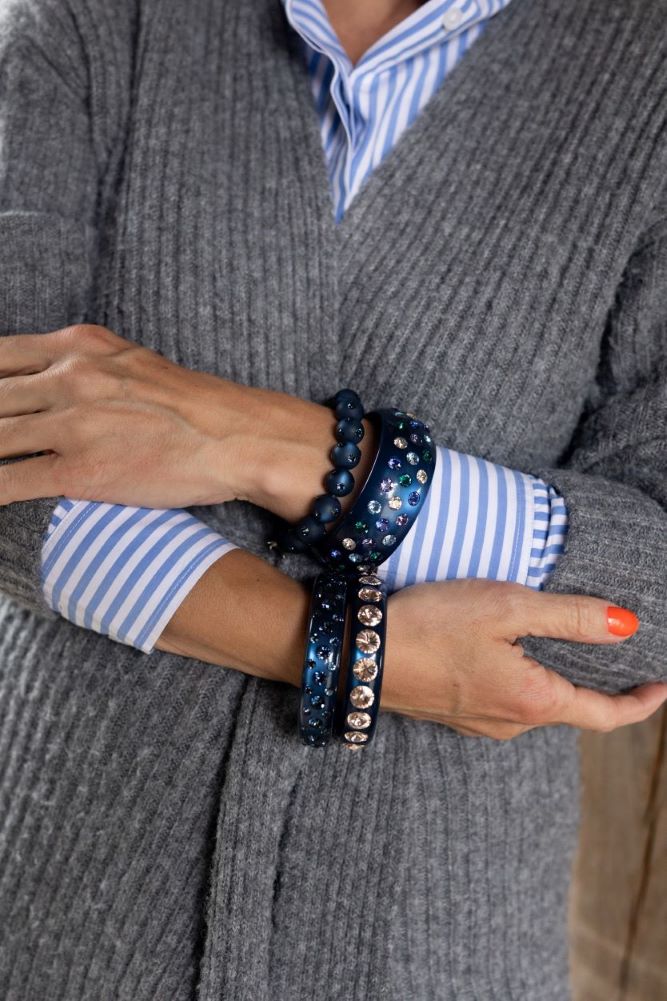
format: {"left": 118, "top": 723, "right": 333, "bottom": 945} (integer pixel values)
{"left": 501, "top": 585, "right": 639, "bottom": 643}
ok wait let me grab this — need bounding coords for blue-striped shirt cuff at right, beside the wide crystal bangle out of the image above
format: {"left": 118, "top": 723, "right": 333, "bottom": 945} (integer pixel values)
{"left": 378, "top": 445, "right": 567, "bottom": 591}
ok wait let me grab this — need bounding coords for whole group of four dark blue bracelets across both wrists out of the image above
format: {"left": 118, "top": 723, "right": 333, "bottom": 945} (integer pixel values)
{"left": 268, "top": 389, "right": 436, "bottom": 750}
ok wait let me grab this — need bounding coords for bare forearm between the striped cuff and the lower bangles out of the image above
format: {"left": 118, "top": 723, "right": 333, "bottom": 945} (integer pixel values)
{"left": 155, "top": 549, "right": 309, "bottom": 686}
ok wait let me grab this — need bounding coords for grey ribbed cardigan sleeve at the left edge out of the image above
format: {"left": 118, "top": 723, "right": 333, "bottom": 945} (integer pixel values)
{"left": 0, "top": 0, "right": 98, "bottom": 619}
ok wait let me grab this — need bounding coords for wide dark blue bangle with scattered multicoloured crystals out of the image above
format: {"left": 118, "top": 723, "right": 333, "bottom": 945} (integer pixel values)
{"left": 310, "top": 408, "right": 436, "bottom": 573}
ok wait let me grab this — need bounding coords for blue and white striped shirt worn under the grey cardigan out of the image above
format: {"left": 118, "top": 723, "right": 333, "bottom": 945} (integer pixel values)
{"left": 42, "top": 0, "right": 567, "bottom": 653}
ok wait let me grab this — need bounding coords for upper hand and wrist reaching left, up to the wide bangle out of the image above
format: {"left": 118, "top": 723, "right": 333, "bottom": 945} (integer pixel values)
{"left": 0, "top": 323, "right": 373, "bottom": 521}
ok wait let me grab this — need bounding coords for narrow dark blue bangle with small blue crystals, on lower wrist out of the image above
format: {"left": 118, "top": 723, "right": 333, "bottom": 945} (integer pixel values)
{"left": 298, "top": 571, "right": 347, "bottom": 747}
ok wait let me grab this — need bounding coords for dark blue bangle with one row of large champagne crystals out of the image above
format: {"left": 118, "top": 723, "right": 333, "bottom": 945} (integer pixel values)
{"left": 336, "top": 574, "right": 387, "bottom": 750}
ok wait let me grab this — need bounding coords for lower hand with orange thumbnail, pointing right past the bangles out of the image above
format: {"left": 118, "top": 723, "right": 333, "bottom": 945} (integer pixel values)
{"left": 381, "top": 579, "right": 667, "bottom": 740}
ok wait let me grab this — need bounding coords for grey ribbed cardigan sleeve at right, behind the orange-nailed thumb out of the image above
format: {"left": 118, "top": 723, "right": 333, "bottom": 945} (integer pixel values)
{"left": 521, "top": 199, "right": 667, "bottom": 692}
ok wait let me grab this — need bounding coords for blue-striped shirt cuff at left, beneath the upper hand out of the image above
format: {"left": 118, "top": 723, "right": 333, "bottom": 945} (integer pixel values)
{"left": 41, "top": 497, "right": 238, "bottom": 654}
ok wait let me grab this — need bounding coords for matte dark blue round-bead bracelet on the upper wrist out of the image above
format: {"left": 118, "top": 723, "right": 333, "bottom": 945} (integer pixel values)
{"left": 267, "top": 388, "right": 365, "bottom": 553}
